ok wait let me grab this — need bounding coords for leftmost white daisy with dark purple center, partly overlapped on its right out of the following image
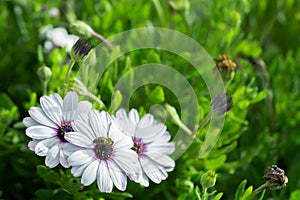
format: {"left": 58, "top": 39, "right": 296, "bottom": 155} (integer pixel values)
{"left": 23, "top": 92, "right": 92, "bottom": 168}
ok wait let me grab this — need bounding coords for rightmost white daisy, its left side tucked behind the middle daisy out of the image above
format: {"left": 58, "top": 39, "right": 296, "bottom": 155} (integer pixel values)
{"left": 116, "top": 109, "right": 175, "bottom": 187}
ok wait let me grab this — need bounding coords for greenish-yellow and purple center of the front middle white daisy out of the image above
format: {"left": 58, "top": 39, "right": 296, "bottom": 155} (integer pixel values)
{"left": 93, "top": 137, "right": 114, "bottom": 160}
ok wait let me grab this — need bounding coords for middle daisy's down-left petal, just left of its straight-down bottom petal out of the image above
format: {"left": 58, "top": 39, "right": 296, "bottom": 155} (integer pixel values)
{"left": 81, "top": 160, "right": 99, "bottom": 186}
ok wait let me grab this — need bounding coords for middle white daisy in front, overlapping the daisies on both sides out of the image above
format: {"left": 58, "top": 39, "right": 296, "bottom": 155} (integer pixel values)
{"left": 65, "top": 110, "right": 137, "bottom": 193}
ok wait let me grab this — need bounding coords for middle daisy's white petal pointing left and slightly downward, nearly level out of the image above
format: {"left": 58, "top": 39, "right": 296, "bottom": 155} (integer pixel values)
{"left": 68, "top": 149, "right": 94, "bottom": 166}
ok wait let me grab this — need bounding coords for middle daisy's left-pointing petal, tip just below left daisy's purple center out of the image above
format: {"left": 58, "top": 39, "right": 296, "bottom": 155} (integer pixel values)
{"left": 65, "top": 132, "right": 93, "bottom": 148}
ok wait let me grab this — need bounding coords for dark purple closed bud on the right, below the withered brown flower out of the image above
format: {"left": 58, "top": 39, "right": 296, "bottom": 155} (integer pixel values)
{"left": 210, "top": 92, "right": 232, "bottom": 116}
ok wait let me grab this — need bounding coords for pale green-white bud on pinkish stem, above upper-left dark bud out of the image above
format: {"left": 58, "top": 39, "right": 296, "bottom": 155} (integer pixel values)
{"left": 70, "top": 20, "right": 94, "bottom": 38}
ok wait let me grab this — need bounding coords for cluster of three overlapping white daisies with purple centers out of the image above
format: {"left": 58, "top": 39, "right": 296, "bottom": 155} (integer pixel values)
{"left": 23, "top": 92, "right": 175, "bottom": 193}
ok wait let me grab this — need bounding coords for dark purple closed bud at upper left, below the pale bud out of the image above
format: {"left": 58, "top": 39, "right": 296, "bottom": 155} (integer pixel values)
{"left": 71, "top": 38, "right": 93, "bottom": 62}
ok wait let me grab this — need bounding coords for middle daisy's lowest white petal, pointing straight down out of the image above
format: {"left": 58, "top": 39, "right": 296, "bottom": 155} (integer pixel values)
{"left": 97, "top": 162, "right": 113, "bottom": 193}
